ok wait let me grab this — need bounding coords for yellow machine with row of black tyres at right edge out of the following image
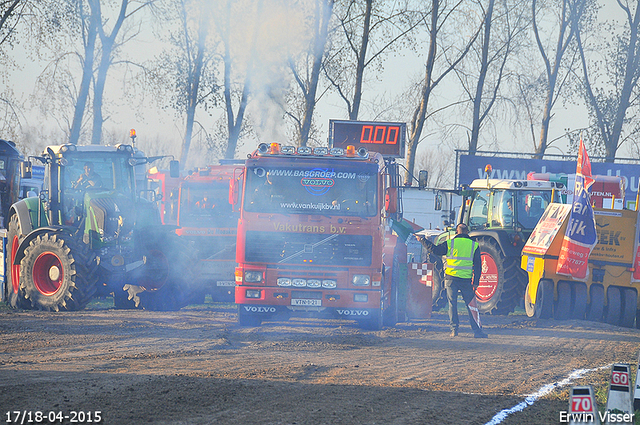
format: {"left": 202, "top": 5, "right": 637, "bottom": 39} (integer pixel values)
{"left": 521, "top": 203, "right": 640, "bottom": 327}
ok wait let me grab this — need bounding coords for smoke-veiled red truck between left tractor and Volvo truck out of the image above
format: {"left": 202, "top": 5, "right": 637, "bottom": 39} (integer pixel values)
{"left": 149, "top": 164, "right": 241, "bottom": 303}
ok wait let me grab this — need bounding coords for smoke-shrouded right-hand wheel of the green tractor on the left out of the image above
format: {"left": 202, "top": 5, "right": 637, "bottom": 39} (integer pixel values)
{"left": 137, "top": 233, "right": 196, "bottom": 311}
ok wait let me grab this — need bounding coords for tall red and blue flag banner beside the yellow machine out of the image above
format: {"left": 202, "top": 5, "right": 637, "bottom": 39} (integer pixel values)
{"left": 556, "top": 139, "right": 598, "bottom": 281}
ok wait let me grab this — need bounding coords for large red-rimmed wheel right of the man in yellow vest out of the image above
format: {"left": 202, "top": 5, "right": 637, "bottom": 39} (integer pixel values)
{"left": 476, "top": 237, "right": 527, "bottom": 315}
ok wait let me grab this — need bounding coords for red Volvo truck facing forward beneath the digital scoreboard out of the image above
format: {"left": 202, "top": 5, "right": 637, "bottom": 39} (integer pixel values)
{"left": 230, "top": 122, "right": 407, "bottom": 329}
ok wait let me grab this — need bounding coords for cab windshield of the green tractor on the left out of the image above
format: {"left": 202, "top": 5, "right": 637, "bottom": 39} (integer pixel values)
{"left": 62, "top": 153, "right": 134, "bottom": 195}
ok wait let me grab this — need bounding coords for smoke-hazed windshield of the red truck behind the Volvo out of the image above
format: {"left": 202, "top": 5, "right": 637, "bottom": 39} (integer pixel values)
{"left": 178, "top": 180, "right": 238, "bottom": 227}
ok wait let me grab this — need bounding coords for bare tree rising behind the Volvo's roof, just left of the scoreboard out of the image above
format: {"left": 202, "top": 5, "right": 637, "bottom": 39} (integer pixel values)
{"left": 286, "top": 0, "right": 334, "bottom": 146}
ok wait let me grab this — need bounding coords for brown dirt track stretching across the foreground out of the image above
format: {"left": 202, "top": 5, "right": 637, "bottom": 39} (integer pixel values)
{"left": 0, "top": 304, "right": 640, "bottom": 425}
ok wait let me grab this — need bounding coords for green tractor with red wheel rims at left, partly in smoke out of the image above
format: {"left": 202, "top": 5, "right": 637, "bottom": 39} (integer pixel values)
{"left": 5, "top": 144, "right": 194, "bottom": 311}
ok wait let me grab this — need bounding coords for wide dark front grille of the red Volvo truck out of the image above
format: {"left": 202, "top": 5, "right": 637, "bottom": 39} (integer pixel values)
{"left": 245, "top": 231, "right": 373, "bottom": 266}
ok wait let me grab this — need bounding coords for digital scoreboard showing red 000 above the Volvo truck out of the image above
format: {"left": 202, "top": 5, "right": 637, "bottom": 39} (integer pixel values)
{"left": 329, "top": 120, "right": 407, "bottom": 158}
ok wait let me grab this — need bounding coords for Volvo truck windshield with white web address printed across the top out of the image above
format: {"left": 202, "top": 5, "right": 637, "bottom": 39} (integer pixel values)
{"left": 243, "top": 160, "right": 380, "bottom": 217}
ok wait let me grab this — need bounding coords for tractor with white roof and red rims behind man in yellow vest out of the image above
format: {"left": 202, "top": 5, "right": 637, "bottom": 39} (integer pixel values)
{"left": 425, "top": 179, "right": 565, "bottom": 314}
